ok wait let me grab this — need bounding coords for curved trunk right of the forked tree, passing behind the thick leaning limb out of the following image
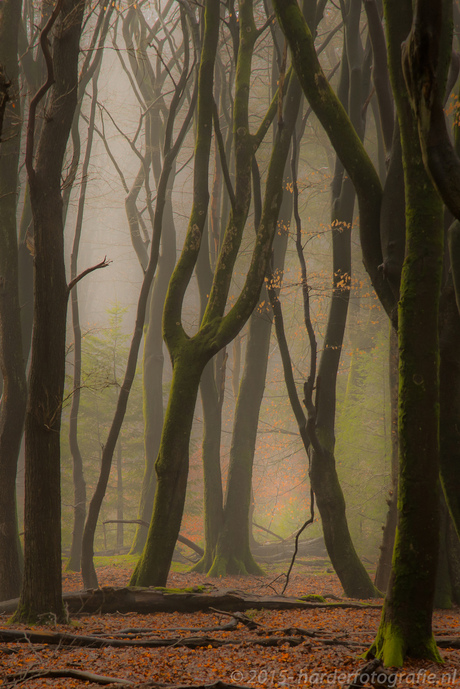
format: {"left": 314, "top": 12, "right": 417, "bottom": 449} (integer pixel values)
{"left": 310, "top": 2, "right": 377, "bottom": 598}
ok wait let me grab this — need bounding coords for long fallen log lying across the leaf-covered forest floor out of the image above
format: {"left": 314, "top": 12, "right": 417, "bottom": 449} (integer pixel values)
{"left": 0, "top": 586, "right": 382, "bottom": 615}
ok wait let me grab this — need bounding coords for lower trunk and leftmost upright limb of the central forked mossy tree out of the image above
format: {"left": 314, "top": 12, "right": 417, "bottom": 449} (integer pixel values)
{"left": 131, "top": 0, "right": 220, "bottom": 586}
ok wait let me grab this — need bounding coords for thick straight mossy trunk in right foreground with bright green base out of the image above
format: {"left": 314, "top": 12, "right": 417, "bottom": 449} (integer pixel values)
{"left": 364, "top": 1, "right": 444, "bottom": 667}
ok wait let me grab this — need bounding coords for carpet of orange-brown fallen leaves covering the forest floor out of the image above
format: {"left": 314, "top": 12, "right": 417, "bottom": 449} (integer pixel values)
{"left": 0, "top": 567, "right": 460, "bottom": 689}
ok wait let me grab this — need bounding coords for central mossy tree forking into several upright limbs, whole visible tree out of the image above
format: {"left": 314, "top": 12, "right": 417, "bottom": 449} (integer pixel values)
{"left": 131, "top": 0, "right": 306, "bottom": 585}
